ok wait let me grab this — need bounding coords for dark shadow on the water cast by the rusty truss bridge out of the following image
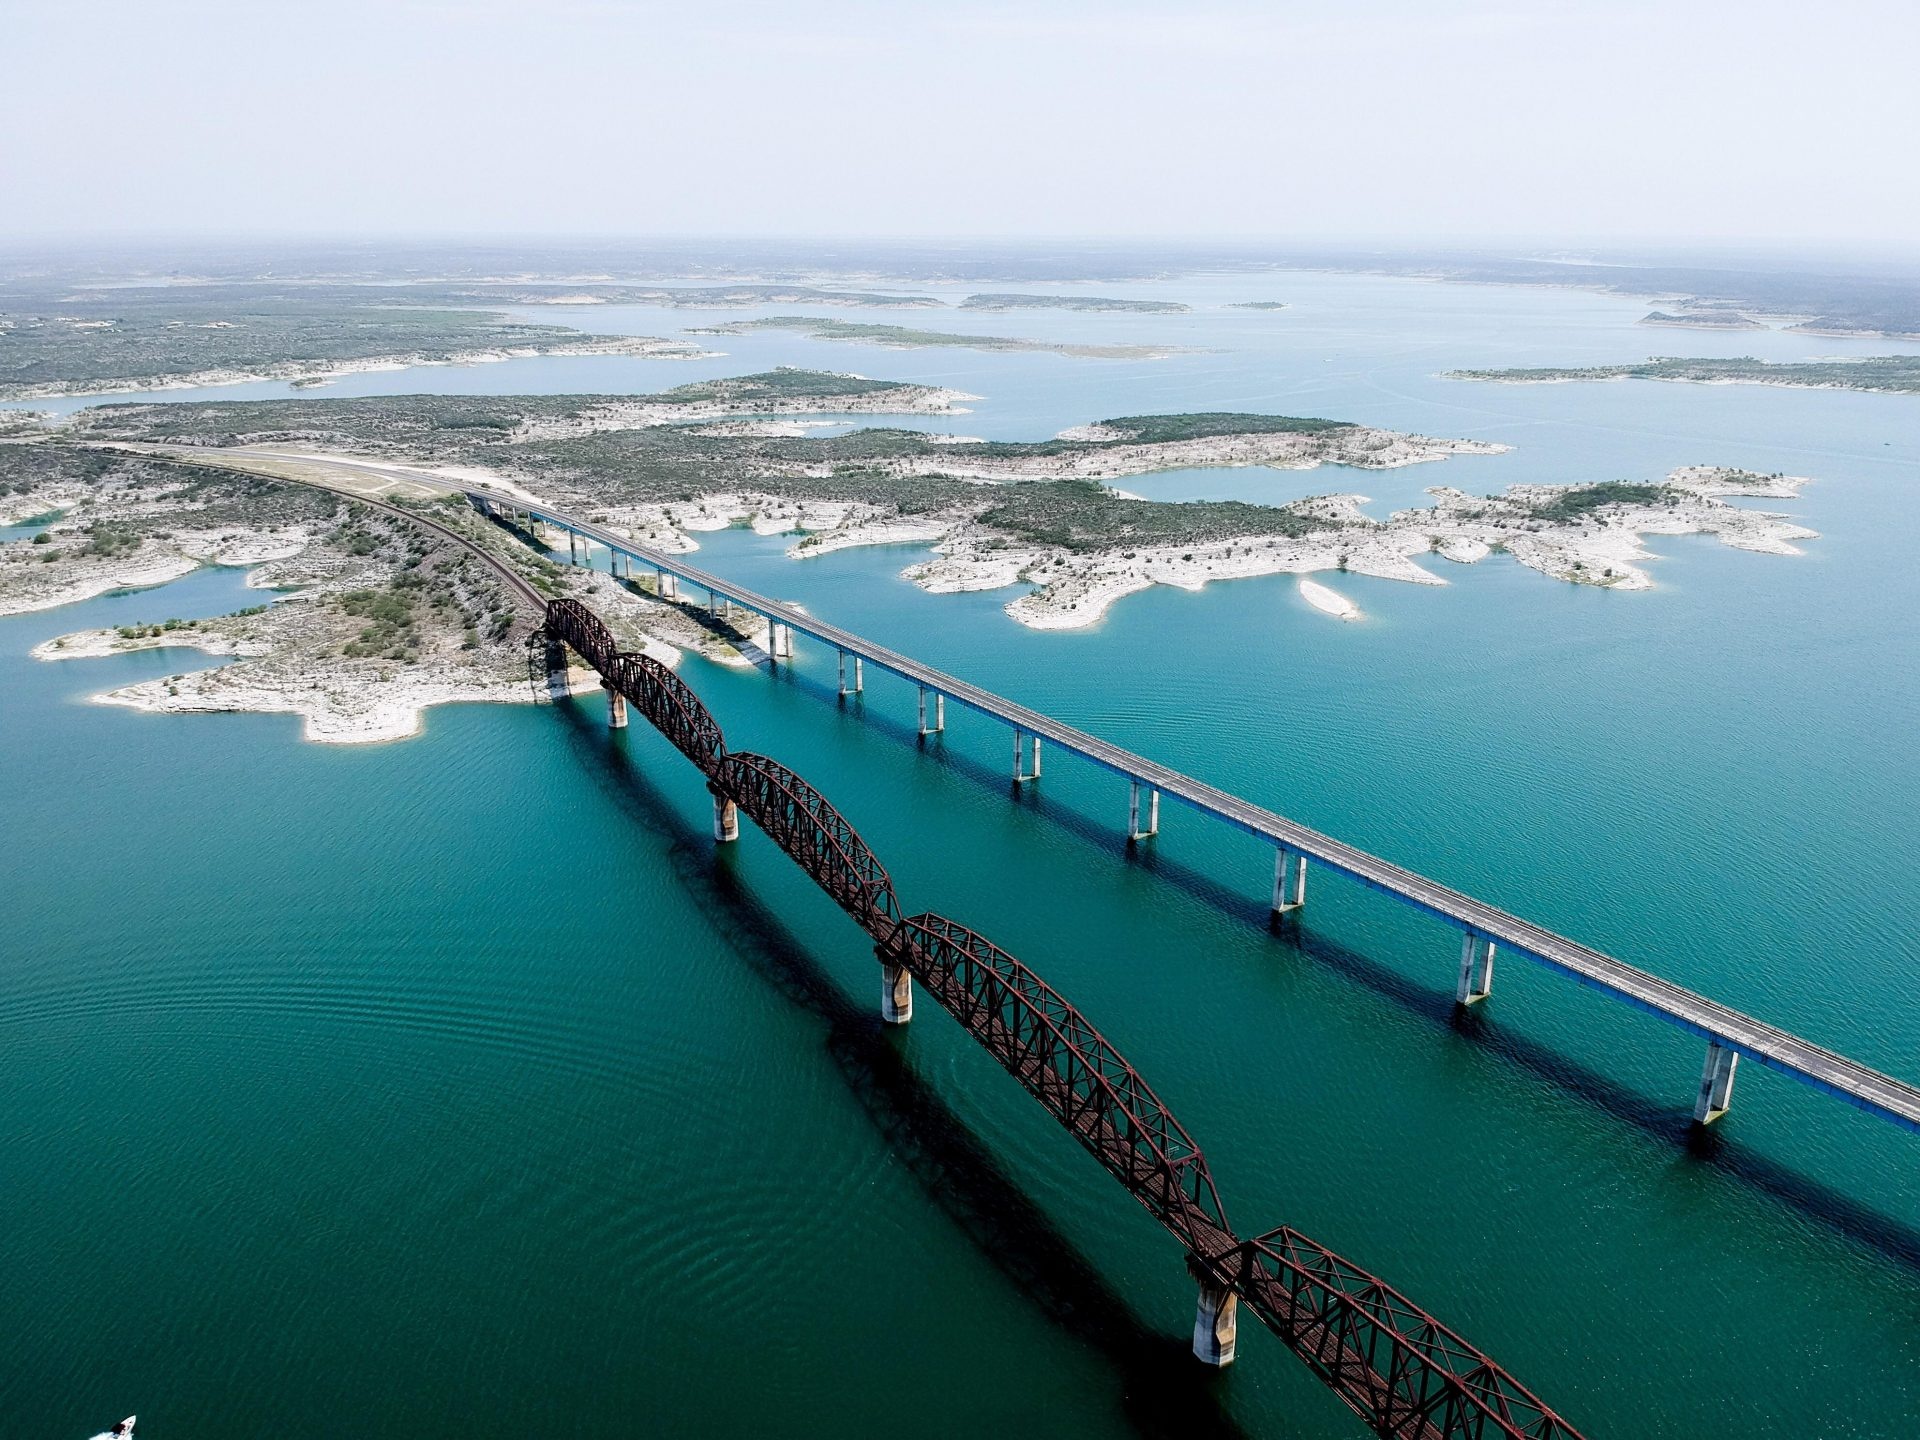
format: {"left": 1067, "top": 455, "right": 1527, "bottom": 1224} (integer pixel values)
{"left": 553, "top": 705, "right": 1246, "bottom": 1440}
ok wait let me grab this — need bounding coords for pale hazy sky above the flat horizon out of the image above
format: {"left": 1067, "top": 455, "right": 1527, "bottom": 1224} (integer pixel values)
{"left": 0, "top": 0, "right": 1920, "bottom": 248}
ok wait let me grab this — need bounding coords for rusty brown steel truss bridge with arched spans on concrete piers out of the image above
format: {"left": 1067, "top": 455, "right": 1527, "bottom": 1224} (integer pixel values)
{"left": 534, "top": 599, "right": 1580, "bottom": 1440}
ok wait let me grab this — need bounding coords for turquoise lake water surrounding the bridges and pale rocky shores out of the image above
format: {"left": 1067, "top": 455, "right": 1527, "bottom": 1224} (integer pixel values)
{"left": 0, "top": 275, "right": 1920, "bottom": 1440}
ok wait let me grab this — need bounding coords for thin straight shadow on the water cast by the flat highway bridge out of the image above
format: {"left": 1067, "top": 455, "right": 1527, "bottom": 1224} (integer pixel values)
{"left": 741, "top": 666, "right": 1920, "bottom": 1269}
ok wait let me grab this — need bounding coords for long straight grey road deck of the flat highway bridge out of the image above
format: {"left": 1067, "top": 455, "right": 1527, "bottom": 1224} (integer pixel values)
{"left": 187, "top": 451, "right": 1920, "bottom": 1131}
